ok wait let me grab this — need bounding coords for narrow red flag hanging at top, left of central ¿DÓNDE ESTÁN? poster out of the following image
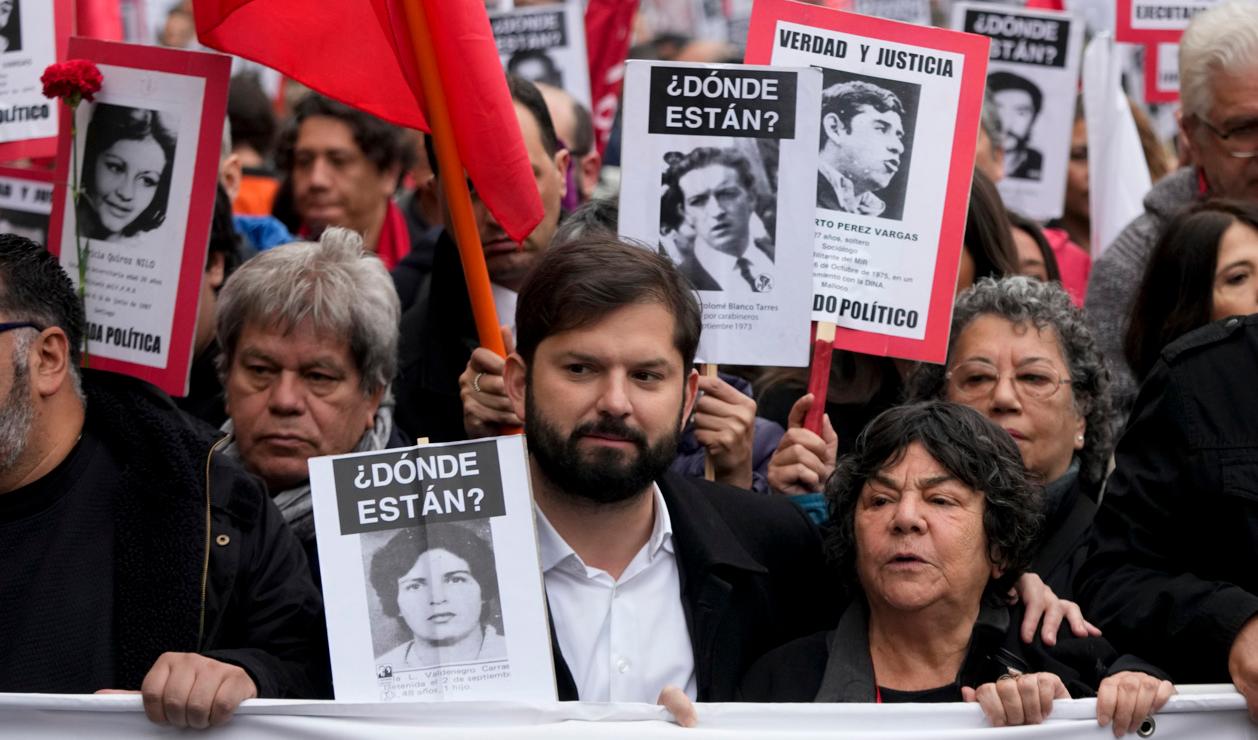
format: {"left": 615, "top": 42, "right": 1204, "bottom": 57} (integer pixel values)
{"left": 585, "top": 0, "right": 638, "bottom": 154}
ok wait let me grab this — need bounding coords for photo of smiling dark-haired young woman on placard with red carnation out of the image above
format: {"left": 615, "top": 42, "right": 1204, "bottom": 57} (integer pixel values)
{"left": 76, "top": 102, "right": 179, "bottom": 242}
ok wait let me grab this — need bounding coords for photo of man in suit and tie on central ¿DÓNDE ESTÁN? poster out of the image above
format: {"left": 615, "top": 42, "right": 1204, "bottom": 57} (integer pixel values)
{"left": 662, "top": 146, "right": 774, "bottom": 293}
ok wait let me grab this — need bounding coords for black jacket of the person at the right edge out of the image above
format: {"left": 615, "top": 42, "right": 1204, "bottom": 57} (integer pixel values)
{"left": 1076, "top": 316, "right": 1258, "bottom": 683}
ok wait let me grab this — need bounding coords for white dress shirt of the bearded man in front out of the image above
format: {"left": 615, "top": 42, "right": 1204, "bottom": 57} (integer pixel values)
{"left": 533, "top": 486, "right": 696, "bottom": 704}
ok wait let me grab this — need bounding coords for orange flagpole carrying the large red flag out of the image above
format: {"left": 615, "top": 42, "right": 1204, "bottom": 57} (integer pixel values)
{"left": 403, "top": 0, "right": 507, "bottom": 357}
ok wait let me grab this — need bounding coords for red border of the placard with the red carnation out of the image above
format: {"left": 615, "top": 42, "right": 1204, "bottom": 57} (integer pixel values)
{"left": 48, "top": 36, "right": 231, "bottom": 395}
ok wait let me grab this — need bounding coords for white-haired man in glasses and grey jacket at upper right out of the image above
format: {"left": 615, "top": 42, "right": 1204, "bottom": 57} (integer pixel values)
{"left": 1084, "top": 1, "right": 1258, "bottom": 420}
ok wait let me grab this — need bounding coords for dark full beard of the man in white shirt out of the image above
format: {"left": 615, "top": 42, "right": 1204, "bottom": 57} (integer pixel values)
{"left": 525, "top": 388, "right": 682, "bottom": 505}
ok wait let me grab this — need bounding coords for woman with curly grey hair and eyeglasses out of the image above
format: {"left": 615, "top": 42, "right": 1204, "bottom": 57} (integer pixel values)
{"left": 910, "top": 277, "right": 1113, "bottom": 599}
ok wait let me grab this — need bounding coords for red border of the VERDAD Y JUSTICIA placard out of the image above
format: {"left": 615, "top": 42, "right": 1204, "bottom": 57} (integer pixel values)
{"left": 746, "top": 0, "right": 991, "bottom": 362}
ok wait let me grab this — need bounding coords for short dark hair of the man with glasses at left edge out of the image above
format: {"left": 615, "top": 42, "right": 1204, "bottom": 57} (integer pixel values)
{"left": 0, "top": 234, "right": 83, "bottom": 371}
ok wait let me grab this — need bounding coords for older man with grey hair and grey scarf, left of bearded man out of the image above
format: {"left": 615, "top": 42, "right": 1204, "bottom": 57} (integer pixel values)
{"left": 218, "top": 228, "right": 409, "bottom": 581}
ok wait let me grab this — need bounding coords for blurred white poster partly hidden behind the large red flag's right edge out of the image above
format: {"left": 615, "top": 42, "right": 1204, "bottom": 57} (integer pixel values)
{"left": 489, "top": 0, "right": 590, "bottom": 106}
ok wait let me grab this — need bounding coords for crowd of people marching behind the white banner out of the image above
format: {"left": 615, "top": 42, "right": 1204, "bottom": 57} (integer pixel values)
{"left": 0, "top": 1, "right": 1258, "bottom": 735}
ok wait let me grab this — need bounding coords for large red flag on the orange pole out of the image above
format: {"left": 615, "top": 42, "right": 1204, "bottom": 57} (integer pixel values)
{"left": 194, "top": 0, "right": 542, "bottom": 242}
